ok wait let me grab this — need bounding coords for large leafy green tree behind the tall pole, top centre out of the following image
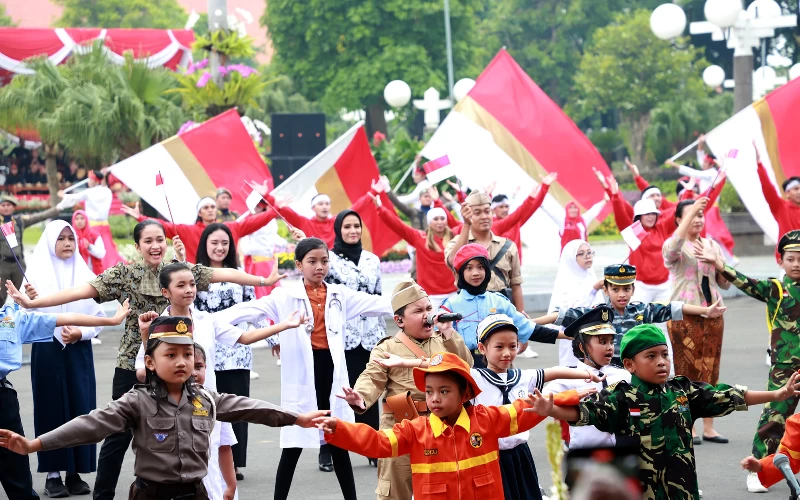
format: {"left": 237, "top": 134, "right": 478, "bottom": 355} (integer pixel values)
{"left": 261, "top": 0, "right": 488, "bottom": 131}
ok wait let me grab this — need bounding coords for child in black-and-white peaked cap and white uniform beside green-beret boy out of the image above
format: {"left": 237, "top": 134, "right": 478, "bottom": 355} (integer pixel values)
{"left": 546, "top": 305, "right": 631, "bottom": 449}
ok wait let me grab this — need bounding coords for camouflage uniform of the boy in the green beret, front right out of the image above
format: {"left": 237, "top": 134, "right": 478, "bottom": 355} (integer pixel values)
{"left": 573, "top": 375, "right": 747, "bottom": 500}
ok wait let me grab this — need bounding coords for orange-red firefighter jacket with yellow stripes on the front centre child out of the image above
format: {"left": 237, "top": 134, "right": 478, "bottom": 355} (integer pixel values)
{"left": 325, "top": 390, "right": 579, "bottom": 500}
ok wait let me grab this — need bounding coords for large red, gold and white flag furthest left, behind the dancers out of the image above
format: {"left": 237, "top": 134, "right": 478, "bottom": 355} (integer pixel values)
{"left": 111, "top": 109, "right": 272, "bottom": 224}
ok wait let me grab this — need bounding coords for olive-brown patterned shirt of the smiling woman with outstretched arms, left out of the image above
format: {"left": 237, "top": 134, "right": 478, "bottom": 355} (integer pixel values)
{"left": 89, "top": 262, "right": 214, "bottom": 371}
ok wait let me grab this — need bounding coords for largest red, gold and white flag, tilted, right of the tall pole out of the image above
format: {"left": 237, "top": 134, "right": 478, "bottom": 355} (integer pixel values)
{"left": 422, "top": 49, "right": 611, "bottom": 261}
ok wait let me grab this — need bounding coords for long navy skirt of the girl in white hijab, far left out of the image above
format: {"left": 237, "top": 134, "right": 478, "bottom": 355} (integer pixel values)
{"left": 31, "top": 340, "right": 97, "bottom": 474}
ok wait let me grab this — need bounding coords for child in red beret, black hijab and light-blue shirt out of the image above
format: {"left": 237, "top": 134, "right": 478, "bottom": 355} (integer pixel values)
{"left": 440, "top": 243, "right": 567, "bottom": 368}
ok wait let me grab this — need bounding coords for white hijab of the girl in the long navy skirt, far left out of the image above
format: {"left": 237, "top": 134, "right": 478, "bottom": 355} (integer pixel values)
{"left": 23, "top": 220, "right": 105, "bottom": 335}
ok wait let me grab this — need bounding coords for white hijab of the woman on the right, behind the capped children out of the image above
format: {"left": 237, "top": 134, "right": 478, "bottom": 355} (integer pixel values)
{"left": 547, "top": 240, "right": 597, "bottom": 312}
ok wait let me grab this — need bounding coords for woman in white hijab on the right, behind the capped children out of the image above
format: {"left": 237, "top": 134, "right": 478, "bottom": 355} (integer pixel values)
{"left": 547, "top": 239, "right": 603, "bottom": 366}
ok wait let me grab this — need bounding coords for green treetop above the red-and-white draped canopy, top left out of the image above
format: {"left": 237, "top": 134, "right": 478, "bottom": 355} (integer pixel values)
{"left": 56, "top": 0, "right": 188, "bottom": 29}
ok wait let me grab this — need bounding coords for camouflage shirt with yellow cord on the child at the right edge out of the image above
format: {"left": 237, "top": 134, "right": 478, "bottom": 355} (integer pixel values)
{"left": 722, "top": 265, "right": 800, "bottom": 366}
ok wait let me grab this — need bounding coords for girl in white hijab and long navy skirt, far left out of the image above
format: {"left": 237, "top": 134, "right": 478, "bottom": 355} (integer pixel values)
{"left": 27, "top": 220, "right": 105, "bottom": 497}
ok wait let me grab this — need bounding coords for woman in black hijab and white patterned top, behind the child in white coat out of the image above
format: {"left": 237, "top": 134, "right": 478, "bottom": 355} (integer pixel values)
{"left": 320, "top": 210, "right": 386, "bottom": 468}
